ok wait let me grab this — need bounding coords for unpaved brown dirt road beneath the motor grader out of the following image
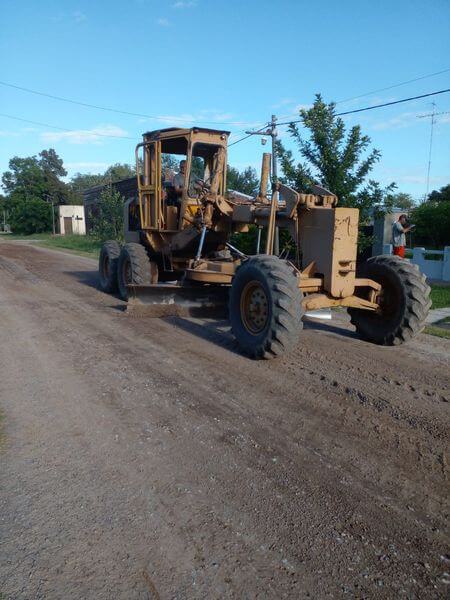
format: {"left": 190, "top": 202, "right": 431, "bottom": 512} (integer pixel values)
{"left": 0, "top": 242, "right": 450, "bottom": 600}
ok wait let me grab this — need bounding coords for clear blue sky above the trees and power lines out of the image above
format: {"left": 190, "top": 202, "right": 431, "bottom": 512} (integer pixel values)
{"left": 0, "top": 0, "right": 450, "bottom": 198}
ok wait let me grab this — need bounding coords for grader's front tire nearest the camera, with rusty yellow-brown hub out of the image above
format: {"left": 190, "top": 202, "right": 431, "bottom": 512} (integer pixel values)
{"left": 229, "top": 255, "right": 303, "bottom": 359}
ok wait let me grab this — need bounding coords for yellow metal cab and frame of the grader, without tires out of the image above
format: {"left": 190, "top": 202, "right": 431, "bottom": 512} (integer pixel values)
{"left": 126, "top": 128, "right": 381, "bottom": 310}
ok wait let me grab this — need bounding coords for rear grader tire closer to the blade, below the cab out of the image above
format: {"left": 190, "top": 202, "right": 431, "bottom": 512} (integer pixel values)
{"left": 117, "top": 242, "right": 152, "bottom": 300}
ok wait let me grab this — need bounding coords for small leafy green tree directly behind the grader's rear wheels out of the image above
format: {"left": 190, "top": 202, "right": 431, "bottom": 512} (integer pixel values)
{"left": 92, "top": 186, "right": 124, "bottom": 241}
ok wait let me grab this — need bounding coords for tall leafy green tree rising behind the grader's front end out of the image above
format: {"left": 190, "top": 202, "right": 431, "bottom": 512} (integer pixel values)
{"left": 278, "top": 94, "right": 391, "bottom": 217}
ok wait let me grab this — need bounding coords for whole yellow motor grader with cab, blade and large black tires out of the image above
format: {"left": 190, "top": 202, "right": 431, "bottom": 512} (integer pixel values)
{"left": 99, "top": 127, "right": 430, "bottom": 358}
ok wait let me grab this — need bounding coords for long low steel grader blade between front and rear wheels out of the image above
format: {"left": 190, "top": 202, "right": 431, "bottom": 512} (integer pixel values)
{"left": 126, "top": 284, "right": 228, "bottom": 318}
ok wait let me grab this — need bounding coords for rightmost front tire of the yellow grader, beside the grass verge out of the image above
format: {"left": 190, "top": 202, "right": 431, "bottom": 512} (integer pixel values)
{"left": 348, "top": 255, "right": 431, "bottom": 346}
